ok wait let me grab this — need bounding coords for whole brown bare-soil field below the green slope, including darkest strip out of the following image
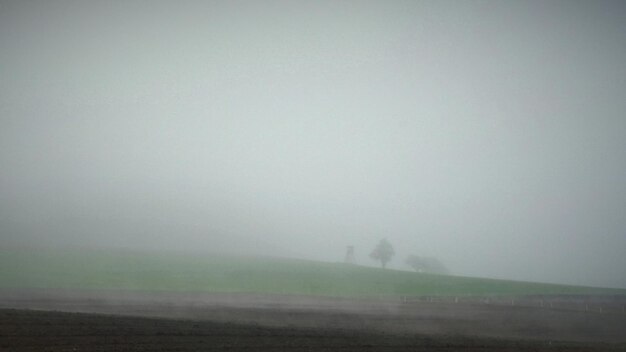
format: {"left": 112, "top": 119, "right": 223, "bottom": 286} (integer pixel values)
{"left": 0, "top": 290, "right": 626, "bottom": 351}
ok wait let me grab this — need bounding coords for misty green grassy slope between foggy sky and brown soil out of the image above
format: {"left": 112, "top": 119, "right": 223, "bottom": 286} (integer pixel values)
{"left": 0, "top": 249, "right": 626, "bottom": 297}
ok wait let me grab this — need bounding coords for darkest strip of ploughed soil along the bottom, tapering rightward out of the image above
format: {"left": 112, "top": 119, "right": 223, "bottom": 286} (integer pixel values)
{"left": 0, "top": 309, "right": 624, "bottom": 351}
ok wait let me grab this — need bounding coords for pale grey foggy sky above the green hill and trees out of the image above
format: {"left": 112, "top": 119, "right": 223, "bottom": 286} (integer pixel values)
{"left": 0, "top": 1, "right": 626, "bottom": 288}
